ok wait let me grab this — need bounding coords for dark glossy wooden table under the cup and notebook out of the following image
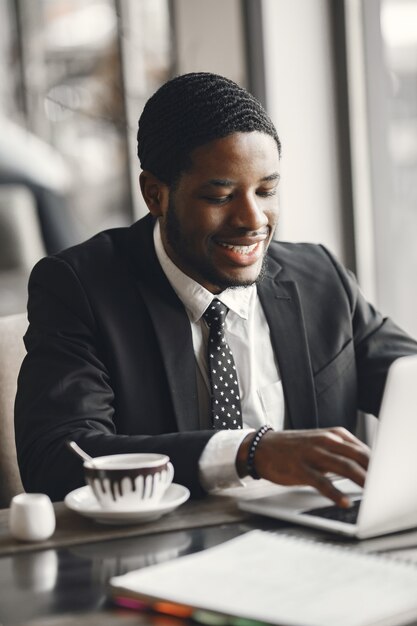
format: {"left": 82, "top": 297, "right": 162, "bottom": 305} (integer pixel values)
{"left": 0, "top": 488, "right": 417, "bottom": 626}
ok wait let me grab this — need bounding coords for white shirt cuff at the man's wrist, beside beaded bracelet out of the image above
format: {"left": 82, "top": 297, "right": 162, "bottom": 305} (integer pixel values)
{"left": 198, "top": 428, "right": 254, "bottom": 492}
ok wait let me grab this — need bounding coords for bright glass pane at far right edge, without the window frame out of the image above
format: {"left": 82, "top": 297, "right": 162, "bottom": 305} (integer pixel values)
{"left": 375, "top": 0, "right": 417, "bottom": 336}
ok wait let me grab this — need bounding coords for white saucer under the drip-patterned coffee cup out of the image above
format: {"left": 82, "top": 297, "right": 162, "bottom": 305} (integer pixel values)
{"left": 64, "top": 483, "right": 190, "bottom": 524}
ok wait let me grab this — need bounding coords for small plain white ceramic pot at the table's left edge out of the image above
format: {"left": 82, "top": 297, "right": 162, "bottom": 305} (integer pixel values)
{"left": 9, "top": 493, "right": 56, "bottom": 541}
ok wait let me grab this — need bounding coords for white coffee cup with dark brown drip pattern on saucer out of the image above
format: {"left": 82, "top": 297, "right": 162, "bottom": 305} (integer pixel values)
{"left": 84, "top": 453, "right": 174, "bottom": 510}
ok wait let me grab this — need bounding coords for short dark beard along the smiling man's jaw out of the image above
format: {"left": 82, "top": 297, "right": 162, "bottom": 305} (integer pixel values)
{"left": 165, "top": 194, "right": 267, "bottom": 291}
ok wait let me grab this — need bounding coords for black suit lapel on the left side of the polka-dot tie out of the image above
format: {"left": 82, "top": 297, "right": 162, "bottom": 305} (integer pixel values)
{"left": 128, "top": 217, "right": 199, "bottom": 431}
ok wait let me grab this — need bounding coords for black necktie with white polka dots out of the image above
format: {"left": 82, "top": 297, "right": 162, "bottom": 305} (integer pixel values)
{"left": 203, "top": 298, "right": 242, "bottom": 429}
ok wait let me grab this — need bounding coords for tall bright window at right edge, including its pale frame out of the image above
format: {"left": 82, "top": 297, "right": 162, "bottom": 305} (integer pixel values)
{"left": 352, "top": 0, "right": 417, "bottom": 336}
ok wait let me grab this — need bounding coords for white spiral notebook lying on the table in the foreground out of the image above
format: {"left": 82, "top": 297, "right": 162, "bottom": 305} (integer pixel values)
{"left": 110, "top": 530, "right": 417, "bottom": 626}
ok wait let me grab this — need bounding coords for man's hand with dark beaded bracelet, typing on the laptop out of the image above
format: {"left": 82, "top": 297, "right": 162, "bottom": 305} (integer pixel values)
{"left": 236, "top": 427, "right": 370, "bottom": 507}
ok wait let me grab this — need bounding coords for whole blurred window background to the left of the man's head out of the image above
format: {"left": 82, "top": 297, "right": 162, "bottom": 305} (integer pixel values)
{"left": 0, "top": 0, "right": 173, "bottom": 315}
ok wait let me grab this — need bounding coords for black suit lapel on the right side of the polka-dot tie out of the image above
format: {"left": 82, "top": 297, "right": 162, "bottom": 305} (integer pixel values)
{"left": 258, "top": 261, "right": 318, "bottom": 429}
